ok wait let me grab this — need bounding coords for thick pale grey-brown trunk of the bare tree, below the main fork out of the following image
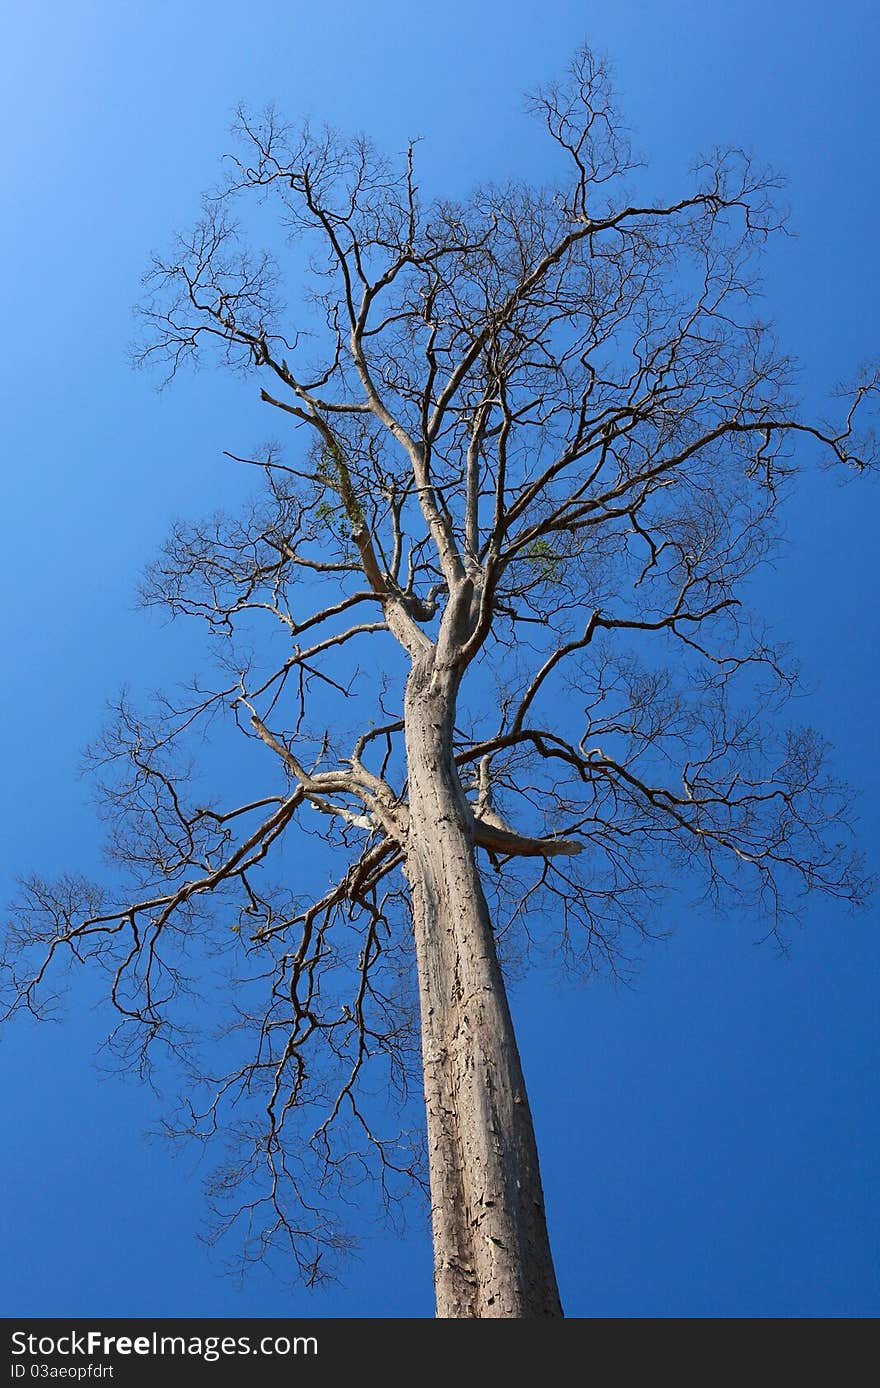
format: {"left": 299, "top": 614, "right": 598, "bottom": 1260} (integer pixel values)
{"left": 405, "top": 652, "right": 562, "bottom": 1317}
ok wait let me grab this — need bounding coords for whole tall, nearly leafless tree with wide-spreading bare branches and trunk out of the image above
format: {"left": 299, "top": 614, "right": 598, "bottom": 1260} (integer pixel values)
{"left": 6, "top": 50, "right": 877, "bottom": 1317}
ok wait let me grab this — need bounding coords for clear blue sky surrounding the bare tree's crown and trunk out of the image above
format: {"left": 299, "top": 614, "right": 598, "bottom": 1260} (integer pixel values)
{"left": 0, "top": 0, "right": 880, "bottom": 1317}
